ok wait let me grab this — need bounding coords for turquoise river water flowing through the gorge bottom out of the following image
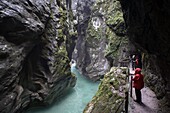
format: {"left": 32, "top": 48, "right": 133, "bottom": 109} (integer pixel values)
{"left": 25, "top": 66, "right": 99, "bottom": 113}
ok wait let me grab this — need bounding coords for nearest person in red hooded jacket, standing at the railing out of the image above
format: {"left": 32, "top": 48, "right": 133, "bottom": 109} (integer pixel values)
{"left": 132, "top": 68, "right": 144, "bottom": 103}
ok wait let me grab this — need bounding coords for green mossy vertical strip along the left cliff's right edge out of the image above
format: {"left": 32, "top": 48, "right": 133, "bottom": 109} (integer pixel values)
{"left": 54, "top": 1, "right": 77, "bottom": 76}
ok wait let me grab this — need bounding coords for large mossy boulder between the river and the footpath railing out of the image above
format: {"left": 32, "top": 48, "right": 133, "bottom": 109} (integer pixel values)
{"left": 83, "top": 67, "right": 128, "bottom": 113}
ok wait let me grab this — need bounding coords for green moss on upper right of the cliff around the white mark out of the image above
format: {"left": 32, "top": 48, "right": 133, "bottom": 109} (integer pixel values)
{"left": 86, "top": 0, "right": 128, "bottom": 59}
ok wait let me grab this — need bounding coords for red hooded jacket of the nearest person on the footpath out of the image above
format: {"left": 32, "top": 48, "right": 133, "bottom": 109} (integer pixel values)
{"left": 132, "top": 68, "right": 144, "bottom": 90}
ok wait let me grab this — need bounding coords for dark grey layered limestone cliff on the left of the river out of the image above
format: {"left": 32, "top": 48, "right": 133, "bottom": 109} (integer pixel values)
{"left": 0, "top": 0, "right": 76, "bottom": 113}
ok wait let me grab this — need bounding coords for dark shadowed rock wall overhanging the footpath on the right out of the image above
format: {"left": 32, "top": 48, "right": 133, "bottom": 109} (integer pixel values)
{"left": 120, "top": 0, "right": 170, "bottom": 111}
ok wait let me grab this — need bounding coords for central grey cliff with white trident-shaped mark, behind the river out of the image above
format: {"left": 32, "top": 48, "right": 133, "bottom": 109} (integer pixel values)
{"left": 73, "top": 0, "right": 128, "bottom": 80}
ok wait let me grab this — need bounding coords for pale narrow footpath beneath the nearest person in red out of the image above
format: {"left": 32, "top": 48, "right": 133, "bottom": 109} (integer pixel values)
{"left": 129, "top": 67, "right": 162, "bottom": 113}
